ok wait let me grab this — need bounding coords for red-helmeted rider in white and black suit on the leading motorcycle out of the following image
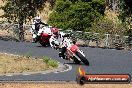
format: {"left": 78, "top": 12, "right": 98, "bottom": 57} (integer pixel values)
{"left": 49, "top": 27, "right": 67, "bottom": 59}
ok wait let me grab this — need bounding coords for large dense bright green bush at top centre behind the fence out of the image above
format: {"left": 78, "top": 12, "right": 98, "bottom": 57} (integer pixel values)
{"left": 48, "top": 0, "right": 105, "bottom": 30}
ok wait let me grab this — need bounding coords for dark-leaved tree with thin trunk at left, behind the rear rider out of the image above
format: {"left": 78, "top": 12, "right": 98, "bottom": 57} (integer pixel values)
{"left": 1, "top": 0, "right": 52, "bottom": 41}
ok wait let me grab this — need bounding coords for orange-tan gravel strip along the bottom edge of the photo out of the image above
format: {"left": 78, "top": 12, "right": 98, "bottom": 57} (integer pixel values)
{"left": 0, "top": 83, "right": 132, "bottom": 88}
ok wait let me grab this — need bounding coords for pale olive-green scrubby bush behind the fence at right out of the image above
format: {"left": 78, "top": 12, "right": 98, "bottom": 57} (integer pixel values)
{"left": 87, "top": 17, "right": 126, "bottom": 35}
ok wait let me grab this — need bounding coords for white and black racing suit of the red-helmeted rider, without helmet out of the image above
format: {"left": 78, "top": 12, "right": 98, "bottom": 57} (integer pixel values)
{"left": 50, "top": 32, "right": 66, "bottom": 59}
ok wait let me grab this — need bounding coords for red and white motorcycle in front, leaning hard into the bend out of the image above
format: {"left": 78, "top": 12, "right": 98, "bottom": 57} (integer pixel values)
{"left": 60, "top": 37, "right": 89, "bottom": 65}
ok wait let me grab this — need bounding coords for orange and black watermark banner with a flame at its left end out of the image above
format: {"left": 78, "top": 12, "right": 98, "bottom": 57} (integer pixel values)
{"left": 76, "top": 67, "right": 131, "bottom": 84}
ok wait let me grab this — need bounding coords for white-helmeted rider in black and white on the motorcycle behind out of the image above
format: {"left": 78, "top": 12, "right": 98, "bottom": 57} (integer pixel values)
{"left": 32, "top": 14, "right": 48, "bottom": 42}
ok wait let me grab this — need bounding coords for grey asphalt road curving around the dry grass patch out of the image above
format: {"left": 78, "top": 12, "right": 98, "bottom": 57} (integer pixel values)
{"left": 0, "top": 40, "right": 132, "bottom": 81}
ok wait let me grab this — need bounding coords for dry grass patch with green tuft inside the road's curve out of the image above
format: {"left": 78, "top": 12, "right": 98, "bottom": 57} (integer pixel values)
{"left": 0, "top": 53, "right": 58, "bottom": 74}
